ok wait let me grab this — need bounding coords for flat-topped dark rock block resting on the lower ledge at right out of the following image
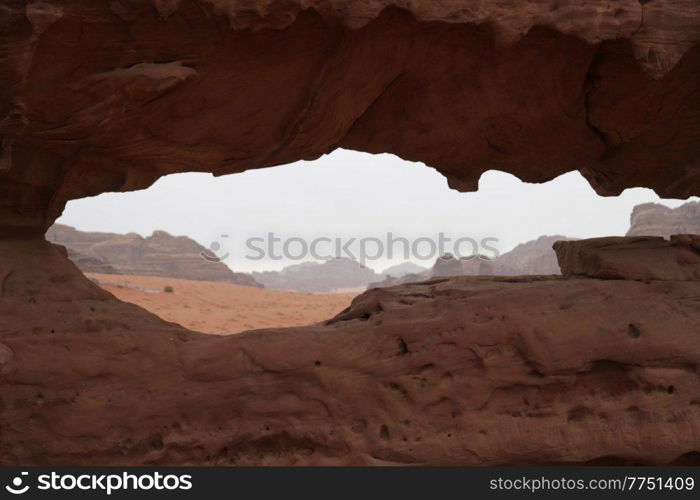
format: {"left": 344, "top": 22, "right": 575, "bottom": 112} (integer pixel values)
{"left": 554, "top": 234, "right": 700, "bottom": 280}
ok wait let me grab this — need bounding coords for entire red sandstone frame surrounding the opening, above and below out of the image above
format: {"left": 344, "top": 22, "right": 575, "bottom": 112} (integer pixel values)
{"left": 0, "top": 0, "right": 700, "bottom": 465}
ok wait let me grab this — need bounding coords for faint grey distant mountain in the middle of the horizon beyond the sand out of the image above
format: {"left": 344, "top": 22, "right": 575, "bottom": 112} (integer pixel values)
{"left": 252, "top": 258, "right": 381, "bottom": 293}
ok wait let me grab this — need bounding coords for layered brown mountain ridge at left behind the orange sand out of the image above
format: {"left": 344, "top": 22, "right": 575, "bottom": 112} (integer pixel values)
{"left": 46, "top": 224, "right": 262, "bottom": 287}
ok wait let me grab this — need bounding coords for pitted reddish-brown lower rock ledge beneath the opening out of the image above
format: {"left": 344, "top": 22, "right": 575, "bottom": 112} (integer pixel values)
{"left": 0, "top": 240, "right": 700, "bottom": 465}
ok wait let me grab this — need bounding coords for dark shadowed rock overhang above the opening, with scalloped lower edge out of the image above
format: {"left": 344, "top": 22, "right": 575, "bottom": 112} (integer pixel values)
{"left": 0, "top": 0, "right": 700, "bottom": 237}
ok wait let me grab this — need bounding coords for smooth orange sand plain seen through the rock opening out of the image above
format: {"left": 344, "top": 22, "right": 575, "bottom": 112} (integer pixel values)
{"left": 87, "top": 273, "right": 354, "bottom": 335}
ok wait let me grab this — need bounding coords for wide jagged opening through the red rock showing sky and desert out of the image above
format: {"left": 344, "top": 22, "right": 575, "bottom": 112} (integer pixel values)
{"left": 47, "top": 150, "right": 696, "bottom": 336}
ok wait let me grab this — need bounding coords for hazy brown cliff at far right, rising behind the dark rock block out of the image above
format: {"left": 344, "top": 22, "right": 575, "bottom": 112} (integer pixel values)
{"left": 627, "top": 201, "right": 700, "bottom": 238}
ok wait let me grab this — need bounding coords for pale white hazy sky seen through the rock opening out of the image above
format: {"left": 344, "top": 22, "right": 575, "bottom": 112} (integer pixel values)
{"left": 58, "top": 150, "right": 696, "bottom": 271}
